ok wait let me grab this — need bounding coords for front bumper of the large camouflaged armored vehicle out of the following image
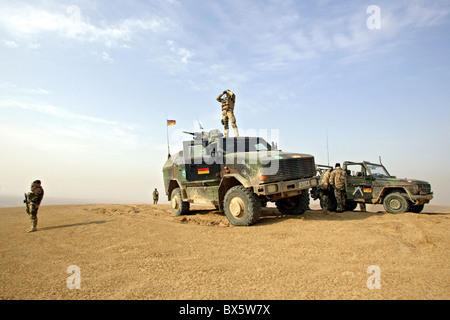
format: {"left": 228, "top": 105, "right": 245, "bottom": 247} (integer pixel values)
{"left": 253, "top": 177, "right": 318, "bottom": 198}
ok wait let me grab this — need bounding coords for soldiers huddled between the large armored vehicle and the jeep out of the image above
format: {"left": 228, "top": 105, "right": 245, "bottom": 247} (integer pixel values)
{"left": 320, "top": 163, "right": 366, "bottom": 213}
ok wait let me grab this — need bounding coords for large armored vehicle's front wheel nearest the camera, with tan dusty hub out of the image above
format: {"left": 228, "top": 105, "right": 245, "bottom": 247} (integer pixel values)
{"left": 223, "top": 186, "right": 261, "bottom": 226}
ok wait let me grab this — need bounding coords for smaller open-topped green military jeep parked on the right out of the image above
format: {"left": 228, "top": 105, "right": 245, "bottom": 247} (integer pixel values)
{"left": 311, "top": 161, "right": 433, "bottom": 213}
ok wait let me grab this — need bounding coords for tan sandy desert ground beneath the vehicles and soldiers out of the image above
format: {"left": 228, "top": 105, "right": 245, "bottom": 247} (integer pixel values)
{"left": 0, "top": 204, "right": 450, "bottom": 300}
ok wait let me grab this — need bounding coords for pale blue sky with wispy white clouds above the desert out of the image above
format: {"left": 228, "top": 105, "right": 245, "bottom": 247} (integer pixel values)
{"left": 0, "top": 0, "right": 450, "bottom": 205}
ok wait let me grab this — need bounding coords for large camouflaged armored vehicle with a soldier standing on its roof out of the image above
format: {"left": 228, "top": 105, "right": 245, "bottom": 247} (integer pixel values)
{"left": 163, "top": 129, "right": 317, "bottom": 226}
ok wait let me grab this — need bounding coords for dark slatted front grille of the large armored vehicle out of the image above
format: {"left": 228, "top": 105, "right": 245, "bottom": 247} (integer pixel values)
{"left": 266, "top": 157, "right": 316, "bottom": 182}
